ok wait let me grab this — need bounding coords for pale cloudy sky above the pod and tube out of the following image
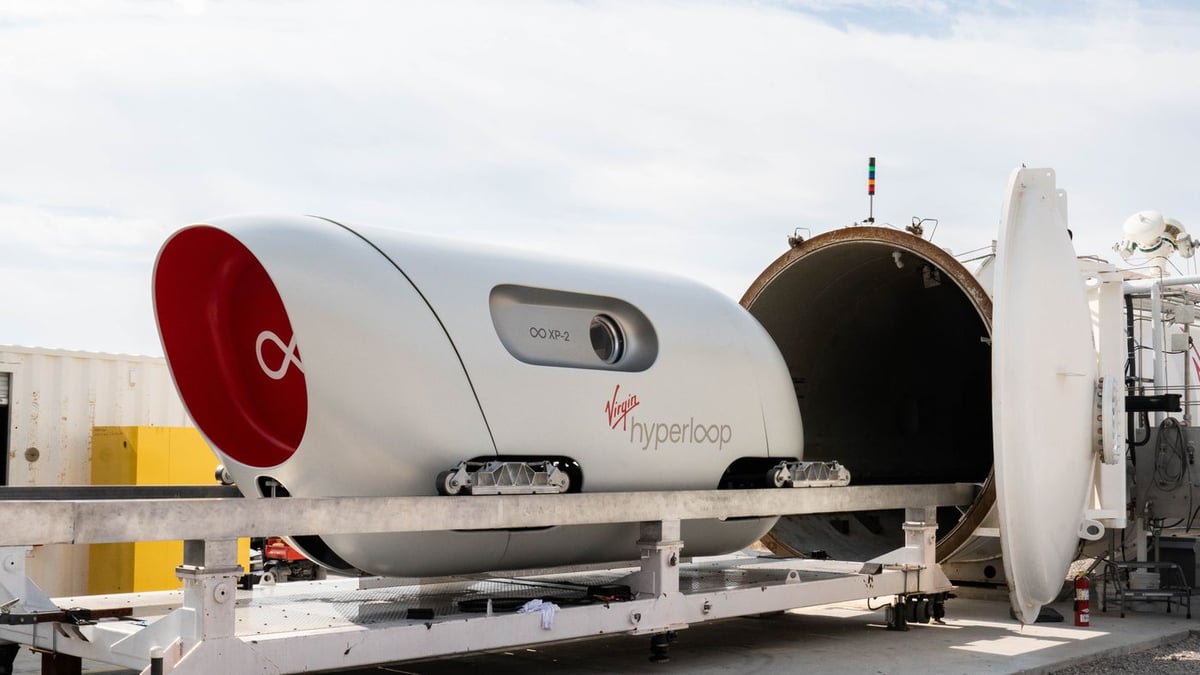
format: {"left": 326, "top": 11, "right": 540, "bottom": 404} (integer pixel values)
{"left": 0, "top": 0, "right": 1200, "bottom": 356}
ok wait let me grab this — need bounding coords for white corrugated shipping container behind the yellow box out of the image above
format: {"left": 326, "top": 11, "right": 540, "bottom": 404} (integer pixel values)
{"left": 0, "top": 345, "right": 192, "bottom": 596}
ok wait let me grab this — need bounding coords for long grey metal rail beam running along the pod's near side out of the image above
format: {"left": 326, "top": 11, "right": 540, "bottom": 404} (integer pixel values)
{"left": 0, "top": 483, "right": 978, "bottom": 546}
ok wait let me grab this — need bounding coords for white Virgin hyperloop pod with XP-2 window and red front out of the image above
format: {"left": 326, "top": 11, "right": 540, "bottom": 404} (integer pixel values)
{"left": 154, "top": 217, "right": 803, "bottom": 575}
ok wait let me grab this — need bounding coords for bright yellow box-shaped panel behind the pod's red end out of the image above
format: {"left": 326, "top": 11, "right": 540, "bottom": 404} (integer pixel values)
{"left": 88, "top": 426, "right": 250, "bottom": 593}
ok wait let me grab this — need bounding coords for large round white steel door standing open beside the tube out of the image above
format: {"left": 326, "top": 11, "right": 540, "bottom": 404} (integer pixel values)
{"left": 992, "top": 168, "right": 1104, "bottom": 623}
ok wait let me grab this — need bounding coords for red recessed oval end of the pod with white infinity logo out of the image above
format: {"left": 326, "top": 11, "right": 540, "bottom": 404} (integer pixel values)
{"left": 154, "top": 226, "right": 308, "bottom": 467}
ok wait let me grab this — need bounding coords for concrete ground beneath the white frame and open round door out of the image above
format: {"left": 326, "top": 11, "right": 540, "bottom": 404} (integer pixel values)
{"left": 9, "top": 598, "right": 1200, "bottom": 675}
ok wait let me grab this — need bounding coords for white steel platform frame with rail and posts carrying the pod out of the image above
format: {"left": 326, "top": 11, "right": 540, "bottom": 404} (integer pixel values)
{"left": 0, "top": 484, "right": 976, "bottom": 674}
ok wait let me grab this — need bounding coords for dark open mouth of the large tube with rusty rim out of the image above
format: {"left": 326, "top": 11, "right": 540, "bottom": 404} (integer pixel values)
{"left": 742, "top": 227, "right": 998, "bottom": 561}
